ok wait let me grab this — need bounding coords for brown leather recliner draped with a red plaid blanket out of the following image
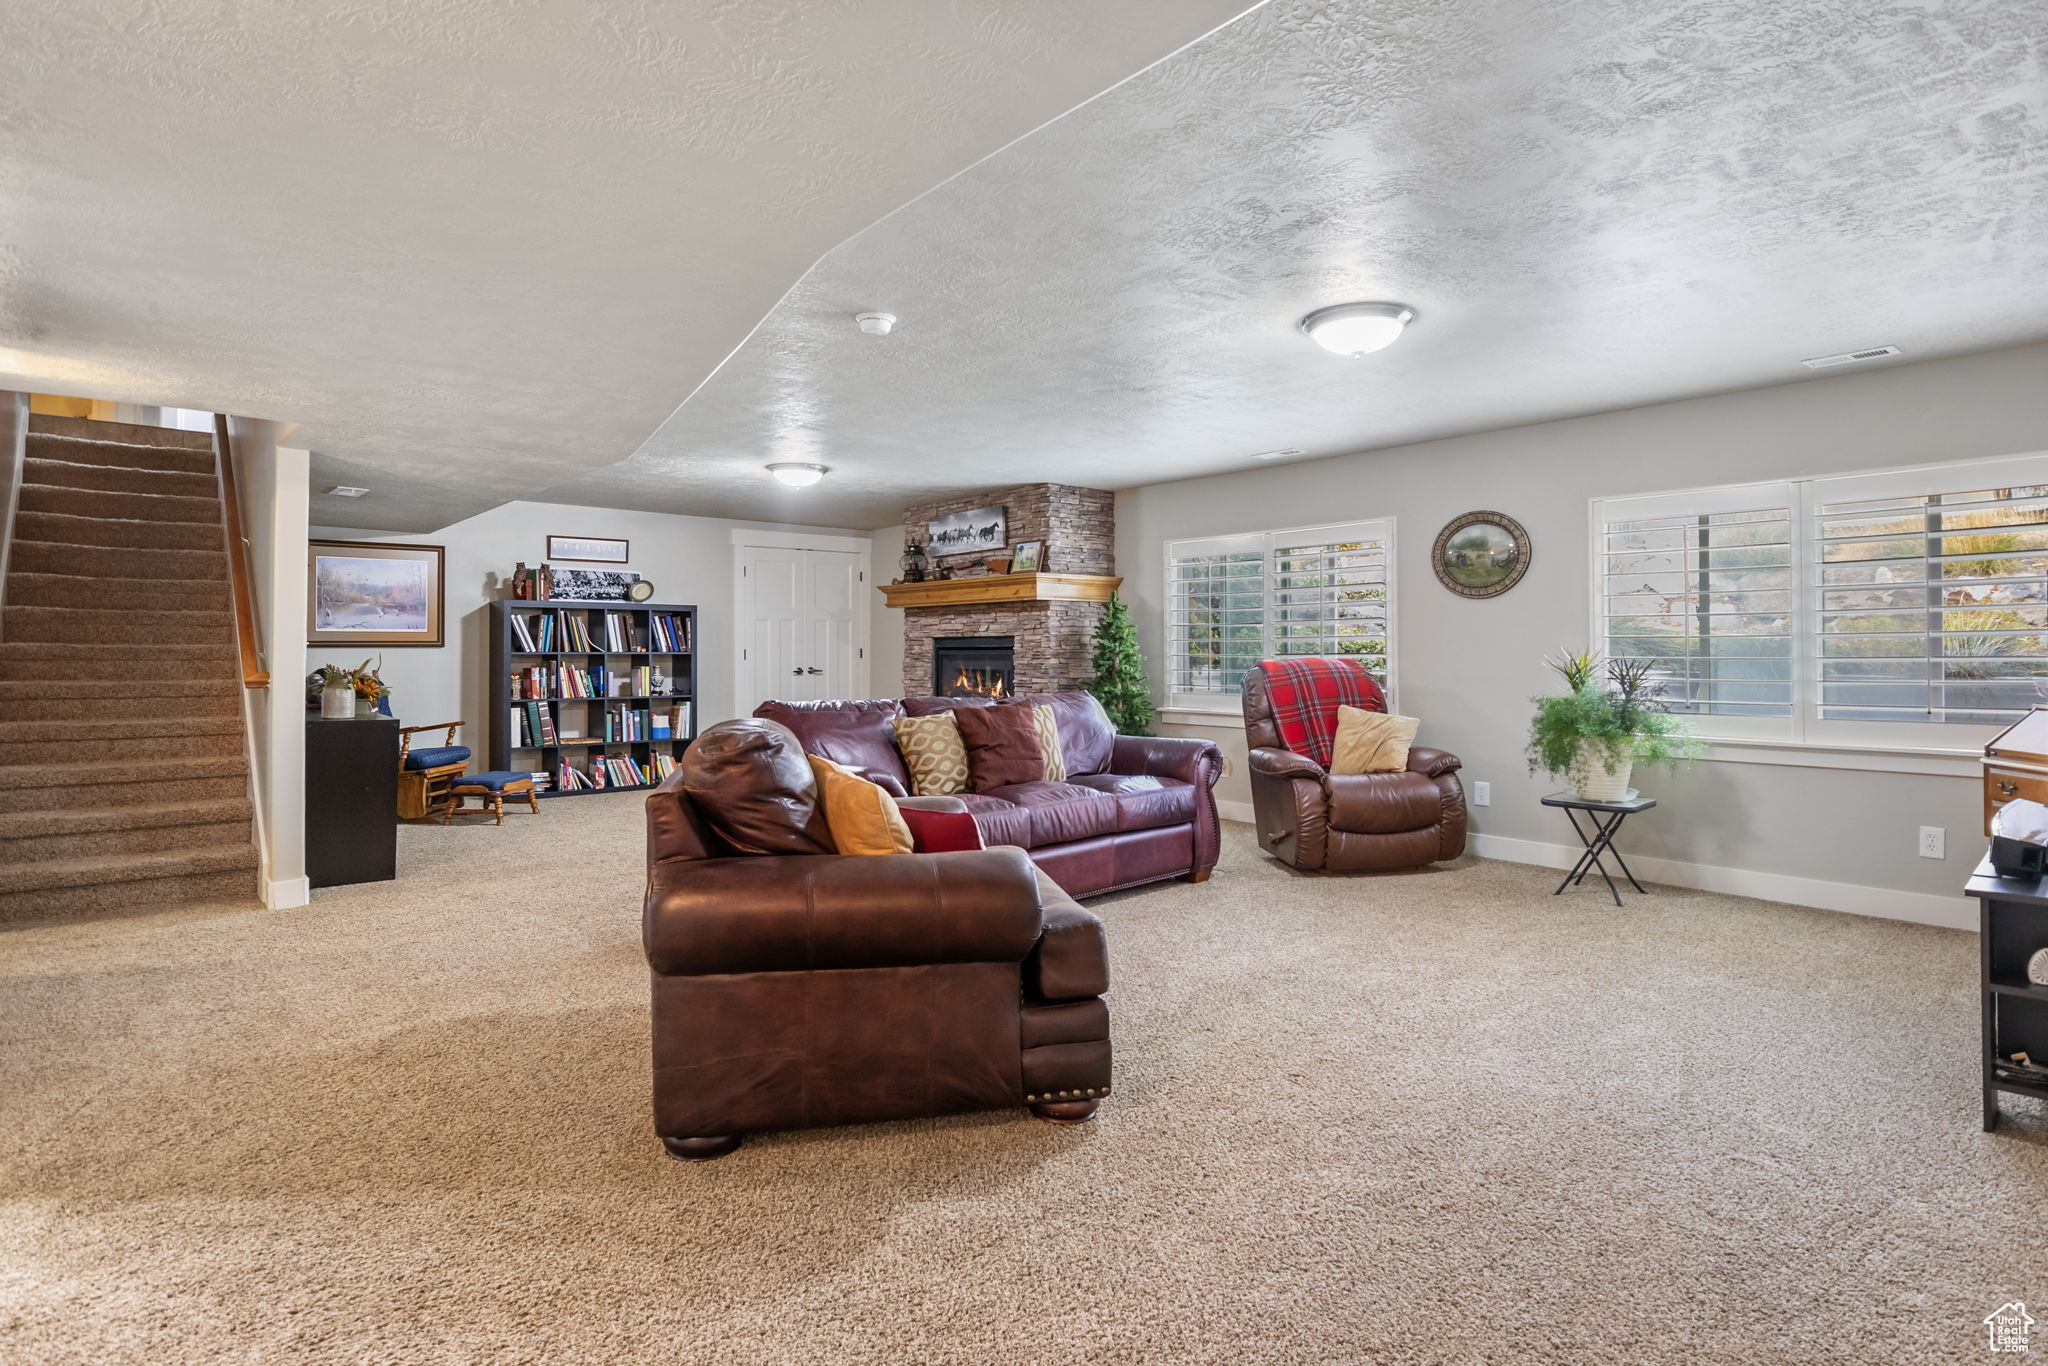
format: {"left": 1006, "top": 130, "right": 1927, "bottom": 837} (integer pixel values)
{"left": 1243, "top": 668, "right": 1464, "bottom": 872}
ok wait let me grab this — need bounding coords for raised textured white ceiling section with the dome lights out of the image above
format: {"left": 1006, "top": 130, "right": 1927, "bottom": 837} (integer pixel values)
{"left": 549, "top": 0, "right": 2048, "bottom": 526}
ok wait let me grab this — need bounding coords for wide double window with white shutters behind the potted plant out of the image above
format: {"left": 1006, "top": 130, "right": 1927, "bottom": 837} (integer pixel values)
{"left": 1593, "top": 457, "right": 2048, "bottom": 745}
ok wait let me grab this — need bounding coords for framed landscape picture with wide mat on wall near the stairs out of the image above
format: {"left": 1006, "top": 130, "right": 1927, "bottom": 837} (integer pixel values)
{"left": 305, "top": 541, "right": 446, "bottom": 645}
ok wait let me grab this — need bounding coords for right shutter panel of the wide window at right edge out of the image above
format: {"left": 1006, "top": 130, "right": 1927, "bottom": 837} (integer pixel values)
{"left": 1812, "top": 471, "right": 2048, "bottom": 725}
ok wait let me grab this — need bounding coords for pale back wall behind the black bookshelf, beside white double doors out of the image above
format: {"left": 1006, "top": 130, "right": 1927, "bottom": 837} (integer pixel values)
{"left": 299, "top": 502, "right": 856, "bottom": 741}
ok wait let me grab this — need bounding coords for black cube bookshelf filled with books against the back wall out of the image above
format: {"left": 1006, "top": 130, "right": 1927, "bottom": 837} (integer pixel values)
{"left": 489, "top": 598, "right": 696, "bottom": 797}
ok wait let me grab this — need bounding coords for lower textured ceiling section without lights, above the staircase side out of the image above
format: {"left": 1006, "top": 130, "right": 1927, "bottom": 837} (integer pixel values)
{"left": 0, "top": 0, "right": 1249, "bottom": 530}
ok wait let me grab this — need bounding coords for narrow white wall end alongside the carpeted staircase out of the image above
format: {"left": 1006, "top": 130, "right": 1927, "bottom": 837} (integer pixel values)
{"left": 227, "top": 428, "right": 309, "bottom": 907}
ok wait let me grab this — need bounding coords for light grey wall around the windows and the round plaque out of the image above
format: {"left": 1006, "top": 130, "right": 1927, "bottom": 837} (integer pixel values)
{"left": 1116, "top": 346, "right": 2048, "bottom": 924}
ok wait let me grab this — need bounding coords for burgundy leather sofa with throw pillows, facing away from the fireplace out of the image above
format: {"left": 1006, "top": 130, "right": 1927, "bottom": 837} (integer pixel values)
{"left": 754, "top": 692, "right": 1223, "bottom": 897}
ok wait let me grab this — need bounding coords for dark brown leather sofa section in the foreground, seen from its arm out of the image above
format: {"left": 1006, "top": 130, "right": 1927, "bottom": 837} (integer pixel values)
{"left": 641, "top": 721, "right": 1110, "bottom": 1161}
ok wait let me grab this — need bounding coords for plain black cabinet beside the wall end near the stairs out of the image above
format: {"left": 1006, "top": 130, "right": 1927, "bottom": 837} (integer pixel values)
{"left": 305, "top": 715, "right": 397, "bottom": 887}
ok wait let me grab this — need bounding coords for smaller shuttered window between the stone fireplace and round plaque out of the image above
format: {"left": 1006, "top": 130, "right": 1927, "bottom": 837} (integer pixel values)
{"left": 1165, "top": 518, "right": 1395, "bottom": 707}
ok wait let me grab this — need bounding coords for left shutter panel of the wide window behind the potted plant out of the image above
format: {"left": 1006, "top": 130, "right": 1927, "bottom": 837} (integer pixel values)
{"left": 1593, "top": 483, "right": 1798, "bottom": 735}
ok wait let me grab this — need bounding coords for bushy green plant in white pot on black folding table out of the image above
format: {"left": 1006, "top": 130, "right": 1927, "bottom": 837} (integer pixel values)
{"left": 1528, "top": 651, "right": 1700, "bottom": 801}
